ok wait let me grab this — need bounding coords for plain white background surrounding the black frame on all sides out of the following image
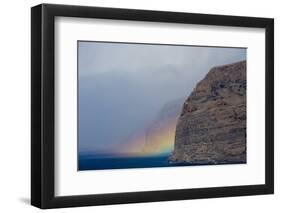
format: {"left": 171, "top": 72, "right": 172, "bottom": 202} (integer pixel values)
{"left": 0, "top": 0, "right": 281, "bottom": 213}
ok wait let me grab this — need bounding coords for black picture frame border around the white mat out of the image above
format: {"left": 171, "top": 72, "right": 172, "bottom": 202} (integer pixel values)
{"left": 31, "top": 4, "right": 274, "bottom": 209}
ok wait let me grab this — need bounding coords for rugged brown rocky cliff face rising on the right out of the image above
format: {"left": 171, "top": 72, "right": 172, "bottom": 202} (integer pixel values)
{"left": 170, "top": 61, "right": 246, "bottom": 164}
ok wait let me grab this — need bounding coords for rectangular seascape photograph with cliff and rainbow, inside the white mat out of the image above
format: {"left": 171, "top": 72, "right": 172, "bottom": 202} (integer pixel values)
{"left": 77, "top": 40, "right": 247, "bottom": 171}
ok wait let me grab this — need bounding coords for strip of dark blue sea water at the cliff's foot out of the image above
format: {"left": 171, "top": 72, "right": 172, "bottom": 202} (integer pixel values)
{"left": 78, "top": 155, "right": 190, "bottom": 170}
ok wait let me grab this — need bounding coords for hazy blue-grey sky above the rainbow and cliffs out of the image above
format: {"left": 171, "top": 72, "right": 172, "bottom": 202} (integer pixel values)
{"left": 78, "top": 42, "right": 246, "bottom": 152}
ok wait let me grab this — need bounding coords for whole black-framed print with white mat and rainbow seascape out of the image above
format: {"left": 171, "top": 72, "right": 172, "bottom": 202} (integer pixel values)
{"left": 31, "top": 4, "right": 274, "bottom": 208}
